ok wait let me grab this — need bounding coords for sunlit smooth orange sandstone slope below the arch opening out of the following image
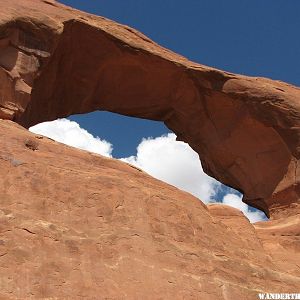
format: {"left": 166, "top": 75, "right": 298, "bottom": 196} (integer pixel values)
{"left": 0, "top": 121, "right": 300, "bottom": 300}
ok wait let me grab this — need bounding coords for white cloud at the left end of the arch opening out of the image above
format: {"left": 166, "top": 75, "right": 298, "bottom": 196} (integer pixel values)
{"left": 29, "top": 119, "right": 112, "bottom": 157}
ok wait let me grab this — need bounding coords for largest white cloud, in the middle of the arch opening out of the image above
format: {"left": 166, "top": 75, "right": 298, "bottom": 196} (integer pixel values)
{"left": 122, "top": 133, "right": 221, "bottom": 203}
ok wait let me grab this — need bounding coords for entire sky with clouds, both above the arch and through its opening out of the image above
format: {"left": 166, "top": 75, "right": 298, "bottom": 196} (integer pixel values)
{"left": 32, "top": 0, "right": 300, "bottom": 222}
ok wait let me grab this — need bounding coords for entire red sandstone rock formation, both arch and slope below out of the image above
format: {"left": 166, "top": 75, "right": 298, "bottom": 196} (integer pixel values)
{"left": 0, "top": 0, "right": 300, "bottom": 299}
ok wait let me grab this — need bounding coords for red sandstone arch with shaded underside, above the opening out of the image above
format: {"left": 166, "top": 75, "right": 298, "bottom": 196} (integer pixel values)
{"left": 0, "top": 0, "right": 300, "bottom": 218}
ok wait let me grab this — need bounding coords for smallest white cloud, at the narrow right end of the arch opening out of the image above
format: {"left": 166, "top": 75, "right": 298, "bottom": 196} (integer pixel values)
{"left": 222, "top": 194, "right": 265, "bottom": 223}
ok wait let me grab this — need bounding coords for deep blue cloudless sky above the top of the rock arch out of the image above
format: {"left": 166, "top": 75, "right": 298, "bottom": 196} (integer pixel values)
{"left": 61, "top": 0, "right": 300, "bottom": 85}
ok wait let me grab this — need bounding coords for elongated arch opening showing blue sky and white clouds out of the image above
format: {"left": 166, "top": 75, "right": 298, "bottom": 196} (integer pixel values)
{"left": 30, "top": 111, "right": 267, "bottom": 222}
